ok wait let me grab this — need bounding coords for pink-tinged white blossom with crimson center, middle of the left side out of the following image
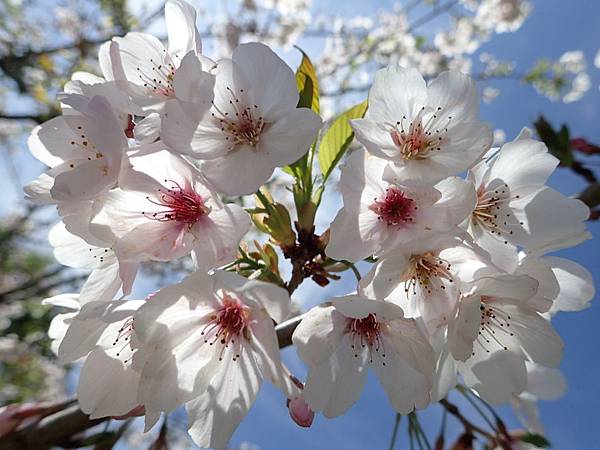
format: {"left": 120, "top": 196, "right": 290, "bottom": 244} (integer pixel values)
{"left": 91, "top": 147, "right": 250, "bottom": 268}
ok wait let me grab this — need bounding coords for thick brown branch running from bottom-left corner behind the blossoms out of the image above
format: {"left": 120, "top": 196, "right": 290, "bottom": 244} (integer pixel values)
{"left": 0, "top": 315, "right": 303, "bottom": 450}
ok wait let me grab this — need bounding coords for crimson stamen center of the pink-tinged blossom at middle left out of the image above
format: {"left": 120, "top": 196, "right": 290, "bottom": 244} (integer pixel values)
{"left": 142, "top": 180, "right": 210, "bottom": 225}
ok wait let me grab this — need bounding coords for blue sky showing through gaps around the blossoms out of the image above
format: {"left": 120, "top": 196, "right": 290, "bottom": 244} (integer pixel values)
{"left": 0, "top": 0, "right": 600, "bottom": 450}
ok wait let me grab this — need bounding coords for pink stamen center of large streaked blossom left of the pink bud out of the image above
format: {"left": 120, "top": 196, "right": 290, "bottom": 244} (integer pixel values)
{"left": 201, "top": 293, "right": 250, "bottom": 361}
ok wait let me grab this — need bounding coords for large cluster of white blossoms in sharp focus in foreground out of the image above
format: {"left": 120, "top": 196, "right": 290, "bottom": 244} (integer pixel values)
{"left": 26, "top": 0, "right": 593, "bottom": 449}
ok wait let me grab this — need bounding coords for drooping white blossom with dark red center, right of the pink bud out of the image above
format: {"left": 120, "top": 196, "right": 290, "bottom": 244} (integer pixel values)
{"left": 292, "top": 295, "right": 434, "bottom": 417}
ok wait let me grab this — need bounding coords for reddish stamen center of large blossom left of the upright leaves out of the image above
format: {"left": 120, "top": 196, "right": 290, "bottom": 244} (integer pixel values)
{"left": 212, "top": 87, "right": 265, "bottom": 149}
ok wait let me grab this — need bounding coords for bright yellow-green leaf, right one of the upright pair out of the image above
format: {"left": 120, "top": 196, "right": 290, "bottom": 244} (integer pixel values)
{"left": 317, "top": 100, "right": 367, "bottom": 182}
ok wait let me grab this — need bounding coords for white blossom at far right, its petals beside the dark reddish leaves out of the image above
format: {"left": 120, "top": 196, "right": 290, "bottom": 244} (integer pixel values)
{"left": 467, "top": 132, "right": 589, "bottom": 271}
